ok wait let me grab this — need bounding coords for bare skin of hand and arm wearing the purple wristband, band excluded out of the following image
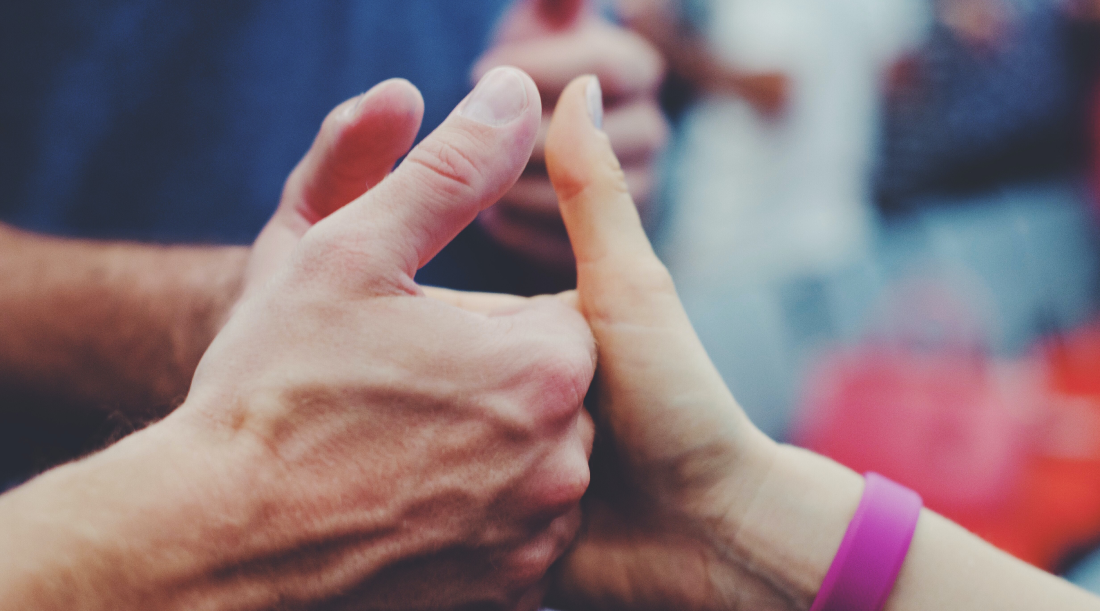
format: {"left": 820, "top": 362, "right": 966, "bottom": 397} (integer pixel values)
{"left": 547, "top": 77, "right": 1100, "bottom": 611}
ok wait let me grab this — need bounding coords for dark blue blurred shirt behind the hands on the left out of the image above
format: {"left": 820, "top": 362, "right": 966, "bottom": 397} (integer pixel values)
{"left": 0, "top": 0, "right": 550, "bottom": 290}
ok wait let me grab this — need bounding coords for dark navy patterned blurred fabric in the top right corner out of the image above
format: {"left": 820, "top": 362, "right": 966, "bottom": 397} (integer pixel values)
{"left": 877, "top": 2, "right": 1088, "bottom": 211}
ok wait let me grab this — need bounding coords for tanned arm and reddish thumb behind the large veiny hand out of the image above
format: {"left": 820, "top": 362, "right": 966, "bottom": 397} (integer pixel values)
{"left": 0, "top": 80, "right": 424, "bottom": 426}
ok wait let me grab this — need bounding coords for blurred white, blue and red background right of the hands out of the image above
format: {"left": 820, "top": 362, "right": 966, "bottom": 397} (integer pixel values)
{"left": 623, "top": 0, "right": 1100, "bottom": 591}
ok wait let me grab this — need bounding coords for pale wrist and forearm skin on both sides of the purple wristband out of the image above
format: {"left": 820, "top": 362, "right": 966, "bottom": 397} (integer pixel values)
{"left": 724, "top": 446, "right": 1100, "bottom": 611}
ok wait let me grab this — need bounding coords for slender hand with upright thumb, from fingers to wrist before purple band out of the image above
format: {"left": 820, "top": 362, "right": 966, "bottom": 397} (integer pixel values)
{"left": 547, "top": 77, "right": 827, "bottom": 610}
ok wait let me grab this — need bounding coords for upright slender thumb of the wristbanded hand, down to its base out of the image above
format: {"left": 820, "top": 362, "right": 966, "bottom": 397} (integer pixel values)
{"left": 547, "top": 76, "right": 758, "bottom": 487}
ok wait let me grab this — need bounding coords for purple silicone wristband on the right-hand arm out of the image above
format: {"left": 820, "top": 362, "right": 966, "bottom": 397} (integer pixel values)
{"left": 810, "top": 473, "right": 923, "bottom": 611}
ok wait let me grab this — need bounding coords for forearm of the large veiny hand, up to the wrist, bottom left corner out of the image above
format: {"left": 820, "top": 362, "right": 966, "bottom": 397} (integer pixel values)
{"left": 0, "top": 416, "right": 277, "bottom": 611}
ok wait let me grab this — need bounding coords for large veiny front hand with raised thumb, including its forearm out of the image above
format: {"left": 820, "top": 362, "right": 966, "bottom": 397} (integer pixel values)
{"left": 0, "top": 68, "right": 595, "bottom": 610}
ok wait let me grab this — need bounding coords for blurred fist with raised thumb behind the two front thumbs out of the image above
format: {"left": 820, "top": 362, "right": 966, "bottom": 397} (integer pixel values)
{"left": 473, "top": 0, "right": 668, "bottom": 270}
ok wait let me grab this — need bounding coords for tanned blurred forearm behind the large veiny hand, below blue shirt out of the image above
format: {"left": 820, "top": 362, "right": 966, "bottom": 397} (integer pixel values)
{"left": 0, "top": 226, "right": 248, "bottom": 421}
